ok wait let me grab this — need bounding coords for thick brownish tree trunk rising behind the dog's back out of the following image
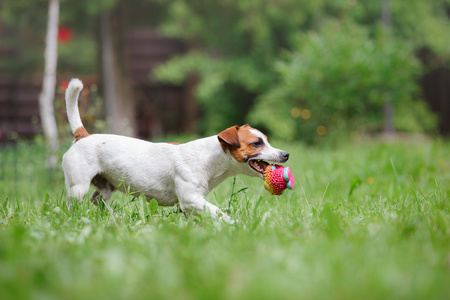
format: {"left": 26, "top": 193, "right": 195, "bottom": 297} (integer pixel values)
{"left": 100, "top": 7, "right": 137, "bottom": 136}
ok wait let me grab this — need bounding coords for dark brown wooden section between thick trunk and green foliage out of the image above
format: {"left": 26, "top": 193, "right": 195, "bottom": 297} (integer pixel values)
{"left": 126, "top": 29, "right": 196, "bottom": 138}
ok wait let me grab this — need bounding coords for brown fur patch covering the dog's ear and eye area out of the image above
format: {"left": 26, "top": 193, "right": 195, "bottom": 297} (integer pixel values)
{"left": 218, "top": 124, "right": 264, "bottom": 162}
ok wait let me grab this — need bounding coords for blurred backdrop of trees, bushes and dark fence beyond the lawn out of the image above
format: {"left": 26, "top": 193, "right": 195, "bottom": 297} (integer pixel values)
{"left": 0, "top": 0, "right": 450, "bottom": 145}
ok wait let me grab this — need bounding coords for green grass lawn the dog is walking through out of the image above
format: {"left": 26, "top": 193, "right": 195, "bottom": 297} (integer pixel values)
{"left": 0, "top": 140, "right": 450, "bottom": 299}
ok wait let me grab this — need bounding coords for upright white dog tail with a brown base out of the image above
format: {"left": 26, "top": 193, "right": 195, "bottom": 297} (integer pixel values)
{"left": 66, "top": 78, "right": 89, "bottom": 142}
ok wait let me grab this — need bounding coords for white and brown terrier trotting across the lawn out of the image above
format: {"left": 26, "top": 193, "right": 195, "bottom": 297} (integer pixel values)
{"left": 62, "top": 78, "right": 289, "bottom": 221}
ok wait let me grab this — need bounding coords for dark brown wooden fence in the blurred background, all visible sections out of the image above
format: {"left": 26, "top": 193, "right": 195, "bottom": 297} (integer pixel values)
{"left": 0, "top": 33, "right": 450, "bottom": 144}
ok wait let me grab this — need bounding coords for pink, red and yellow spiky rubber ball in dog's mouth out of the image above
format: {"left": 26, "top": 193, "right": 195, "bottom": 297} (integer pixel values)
{"left": 264, "top": 165, "right": 294, "bottom": 195}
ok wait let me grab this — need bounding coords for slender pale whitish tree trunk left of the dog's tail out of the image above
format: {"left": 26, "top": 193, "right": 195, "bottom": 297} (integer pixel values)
{"left": 39, "top": 0, "right": 59, "bottom": 168}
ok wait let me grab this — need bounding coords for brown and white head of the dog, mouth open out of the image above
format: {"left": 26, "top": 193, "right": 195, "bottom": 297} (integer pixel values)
{"left": 217, "top": 125, "right": 289, "bottom": 178}
